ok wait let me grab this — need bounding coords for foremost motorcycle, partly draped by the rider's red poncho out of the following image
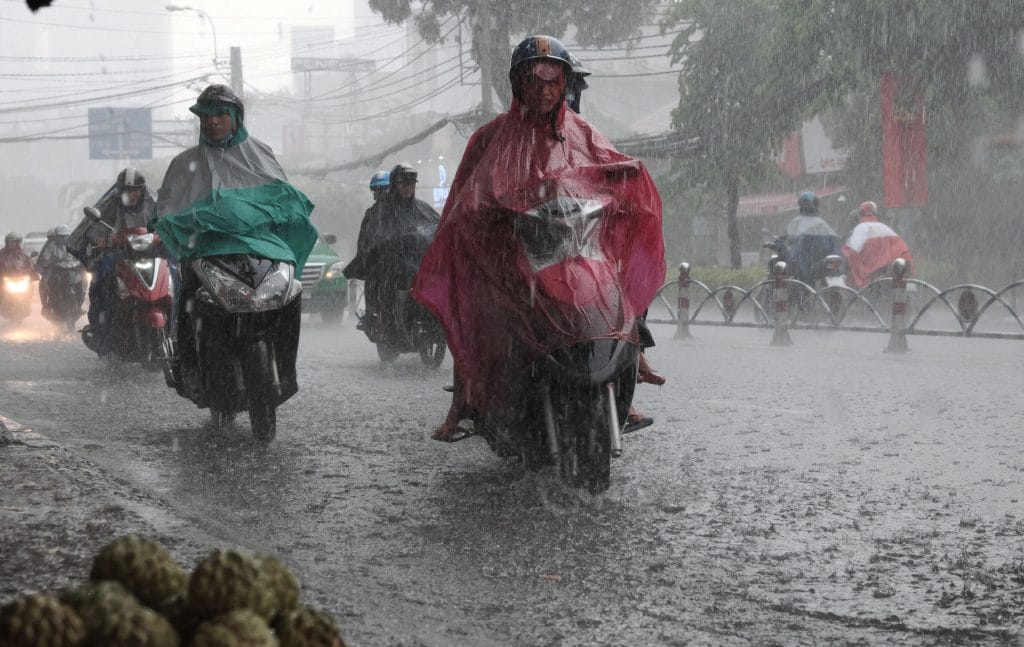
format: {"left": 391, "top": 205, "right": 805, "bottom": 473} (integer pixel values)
{"left": 473, "top": 198, "right": 640, "bottom": 493}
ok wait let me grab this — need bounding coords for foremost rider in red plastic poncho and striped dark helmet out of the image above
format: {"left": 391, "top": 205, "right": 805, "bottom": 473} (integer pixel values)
{"left": 414, "top": 36, "right": 666, "bottom": 440}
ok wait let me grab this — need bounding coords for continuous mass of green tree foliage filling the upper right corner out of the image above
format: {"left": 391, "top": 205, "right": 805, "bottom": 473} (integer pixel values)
{"left": 666, "top": 0, "right": 1024, "bottom": 276}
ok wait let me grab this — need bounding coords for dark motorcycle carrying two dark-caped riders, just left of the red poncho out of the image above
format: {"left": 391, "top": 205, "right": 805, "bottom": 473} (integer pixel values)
{"left": 356, "top": 225, "right": 447, "bottom": 369}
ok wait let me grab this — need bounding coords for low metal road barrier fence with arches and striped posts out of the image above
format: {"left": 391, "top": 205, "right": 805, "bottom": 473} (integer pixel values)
{"left": 647, "top": 259, "right": 1024, "bottom": 352}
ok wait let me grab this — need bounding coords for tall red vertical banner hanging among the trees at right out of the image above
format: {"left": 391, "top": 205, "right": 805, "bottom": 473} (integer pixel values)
{"left": 881, "top": 72, "right": 928, "bottom": 208}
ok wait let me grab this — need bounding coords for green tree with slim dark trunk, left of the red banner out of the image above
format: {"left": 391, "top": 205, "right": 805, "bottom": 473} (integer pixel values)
{"left": 664, "top": 0, "right": 804, "bottom": 268}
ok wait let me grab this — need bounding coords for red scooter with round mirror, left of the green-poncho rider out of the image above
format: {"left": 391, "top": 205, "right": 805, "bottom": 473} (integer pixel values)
{"left": 81, "top": 207, "right": 174, "bottom": 371}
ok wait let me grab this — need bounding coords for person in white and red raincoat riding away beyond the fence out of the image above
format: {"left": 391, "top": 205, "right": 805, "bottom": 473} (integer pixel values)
{"left": 843, "top": 201, "right": 913, "bottom": 289}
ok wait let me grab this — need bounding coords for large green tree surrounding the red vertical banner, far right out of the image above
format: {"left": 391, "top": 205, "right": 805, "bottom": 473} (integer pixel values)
{"left": 773, "top": 0, "right": 1024, "bottom": 281}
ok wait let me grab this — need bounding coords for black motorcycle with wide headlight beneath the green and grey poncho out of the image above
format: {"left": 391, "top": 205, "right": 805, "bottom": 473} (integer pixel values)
{"left": 164, "top": 249, "right": 302, "bottom": 442}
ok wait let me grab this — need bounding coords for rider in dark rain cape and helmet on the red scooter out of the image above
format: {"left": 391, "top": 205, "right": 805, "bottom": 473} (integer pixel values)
{"left": 79, "top": 167, "right": 157, "bottom": 355}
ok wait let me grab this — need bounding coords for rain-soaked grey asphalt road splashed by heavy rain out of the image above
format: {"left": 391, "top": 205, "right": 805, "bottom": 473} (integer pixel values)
{"left": 0, "top": 309, "right": 1024, "bottom": 646}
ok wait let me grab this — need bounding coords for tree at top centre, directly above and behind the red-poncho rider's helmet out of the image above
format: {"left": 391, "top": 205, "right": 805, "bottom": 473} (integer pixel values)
{"left": 370, "top": 0, "right": 660, "bottom": 113}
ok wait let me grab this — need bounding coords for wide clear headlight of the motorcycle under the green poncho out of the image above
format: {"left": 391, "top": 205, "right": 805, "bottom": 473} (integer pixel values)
{"left": 200, "top": 261, "right": 302, "bottom": 312}
